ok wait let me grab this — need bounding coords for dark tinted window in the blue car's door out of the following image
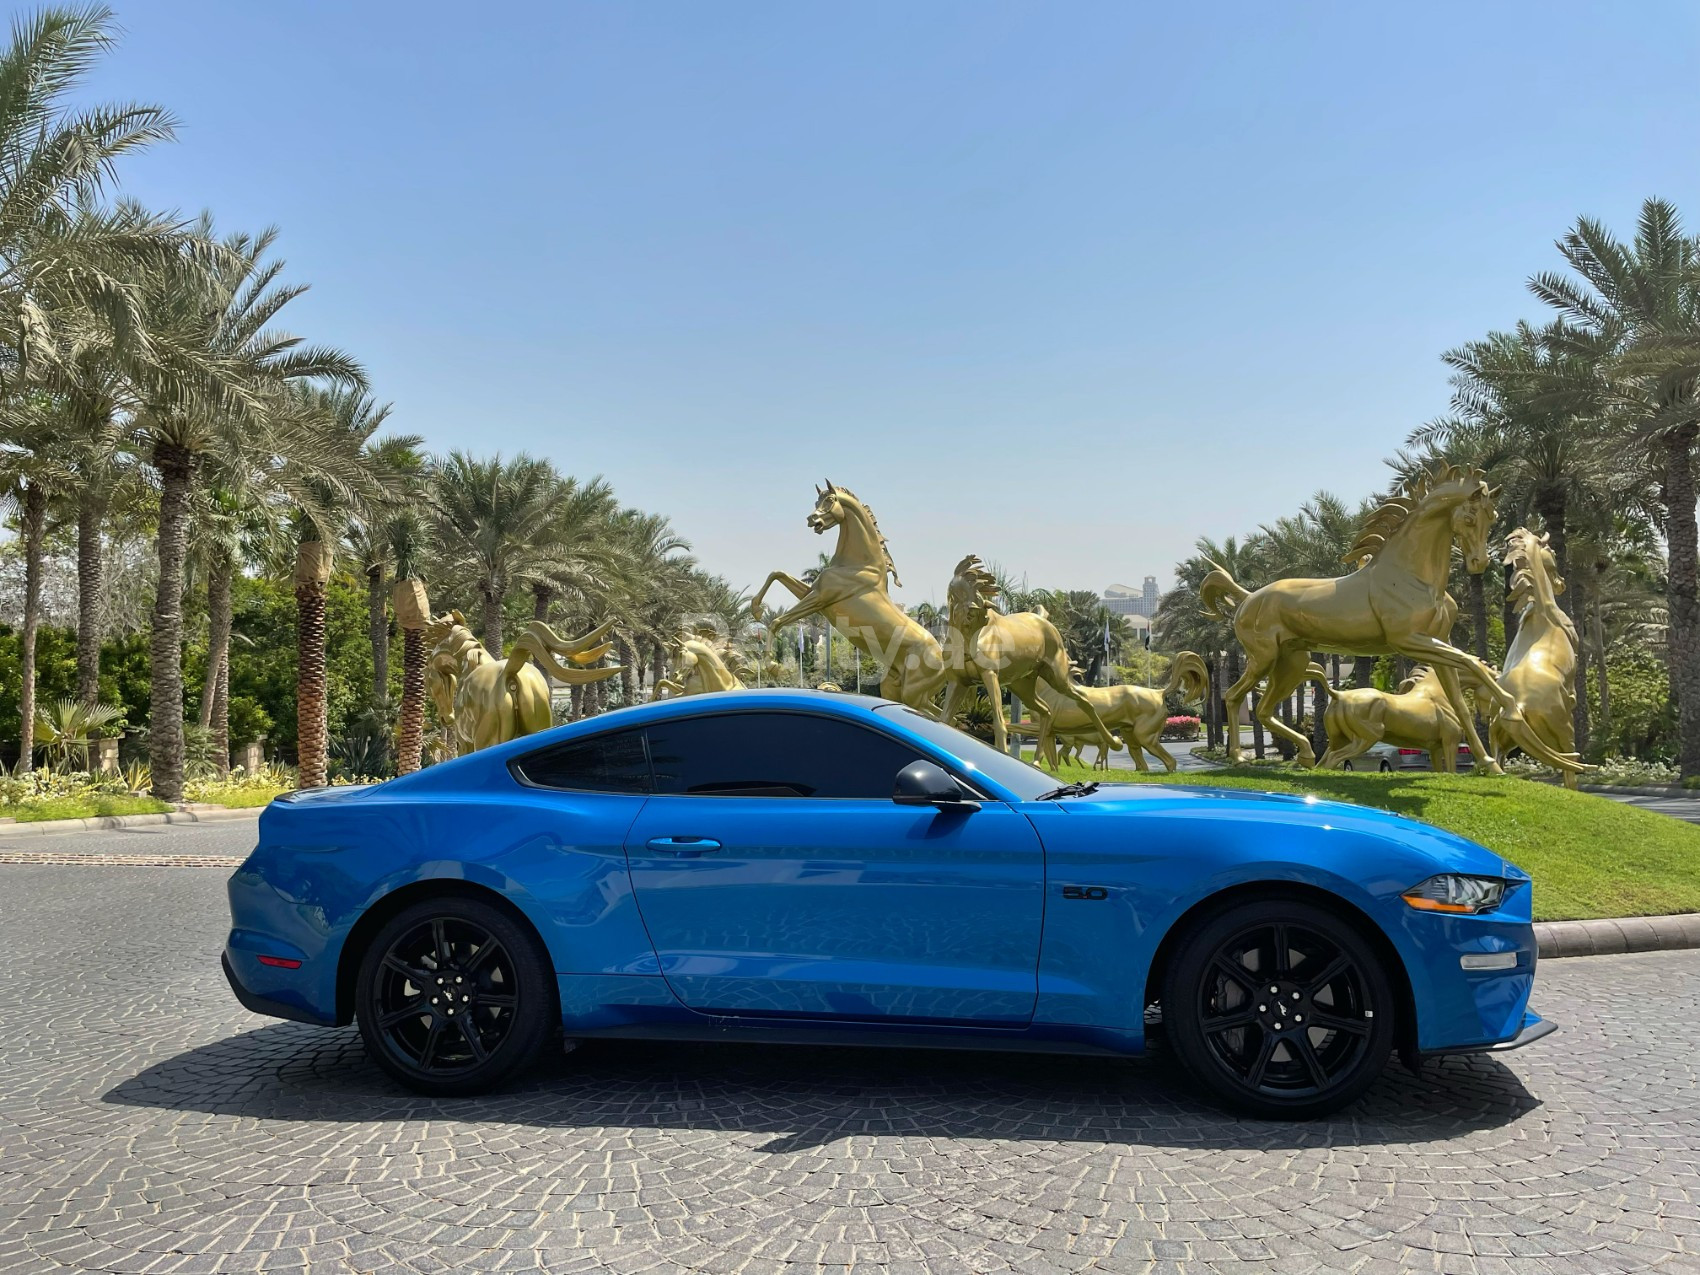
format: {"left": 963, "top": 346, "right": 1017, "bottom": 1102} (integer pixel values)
{"left": 649, "top": 712, "right": 921, "bottom": 801}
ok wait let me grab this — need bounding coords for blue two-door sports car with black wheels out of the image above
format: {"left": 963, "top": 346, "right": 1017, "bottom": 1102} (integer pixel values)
{"left": 224, "top": 690, "right": 1552, "bottom": 1117}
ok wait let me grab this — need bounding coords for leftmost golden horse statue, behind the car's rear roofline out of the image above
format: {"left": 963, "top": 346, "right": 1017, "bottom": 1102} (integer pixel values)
{"left": 425, "top": 610, "right": 621, "bottom": 757}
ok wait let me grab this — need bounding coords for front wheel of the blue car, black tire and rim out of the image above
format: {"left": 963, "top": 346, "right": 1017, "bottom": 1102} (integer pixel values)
{"left": 1163, "top": 899, "right": 1396, "bottom": 1120}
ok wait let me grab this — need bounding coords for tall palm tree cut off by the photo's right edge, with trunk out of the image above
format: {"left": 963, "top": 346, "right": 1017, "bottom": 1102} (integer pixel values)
{"left": 1530, "top": 199, "right": 1700, "bottom": 779}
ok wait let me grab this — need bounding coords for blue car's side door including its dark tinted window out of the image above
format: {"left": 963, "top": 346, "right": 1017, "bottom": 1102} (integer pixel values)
{"left": 626, "top": 711, "right": 1044, "bottom": 1023}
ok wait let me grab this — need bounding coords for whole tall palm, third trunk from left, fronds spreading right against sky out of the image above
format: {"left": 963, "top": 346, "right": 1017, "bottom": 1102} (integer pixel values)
{"left": 129, "top": 218, "right": 366, "bottom": 801}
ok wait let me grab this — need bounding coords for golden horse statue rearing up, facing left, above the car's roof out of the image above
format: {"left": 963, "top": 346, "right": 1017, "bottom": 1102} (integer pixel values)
{"left": 750, "top": 479, "right": 944, "bottom": 716}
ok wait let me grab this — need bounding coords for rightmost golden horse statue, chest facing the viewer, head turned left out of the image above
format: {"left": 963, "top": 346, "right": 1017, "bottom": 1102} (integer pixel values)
{"left": 1488, "top": 527, "right": 1576, "bottom": 789}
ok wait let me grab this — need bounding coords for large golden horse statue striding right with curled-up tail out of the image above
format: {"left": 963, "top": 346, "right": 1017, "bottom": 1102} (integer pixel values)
{"left": 1199, "top": 462, "right": 1583, "bottom": 775}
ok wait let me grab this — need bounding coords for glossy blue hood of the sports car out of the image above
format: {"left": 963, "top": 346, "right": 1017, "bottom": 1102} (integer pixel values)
{"left": 1057, "top": 784, "right": 1527, "bottom": 879}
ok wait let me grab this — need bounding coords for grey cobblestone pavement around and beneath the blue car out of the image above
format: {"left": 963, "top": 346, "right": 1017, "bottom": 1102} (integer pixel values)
{"left": 0, "top": 865, "right": 1700, "bottom": 1275}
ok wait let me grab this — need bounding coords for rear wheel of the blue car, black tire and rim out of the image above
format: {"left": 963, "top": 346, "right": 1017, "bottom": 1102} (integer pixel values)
{"left": 354, "top": 898, "right": 559, "bottom": 1097}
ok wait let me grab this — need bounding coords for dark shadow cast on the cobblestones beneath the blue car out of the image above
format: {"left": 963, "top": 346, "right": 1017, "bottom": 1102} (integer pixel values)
{"left": 104, "top": 1023, "right": 1540, "bottom": 1153}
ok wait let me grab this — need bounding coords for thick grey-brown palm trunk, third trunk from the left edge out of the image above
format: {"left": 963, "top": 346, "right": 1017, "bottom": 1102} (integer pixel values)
{"left": 148, "top": 442, "right": 201, "bottom": 801}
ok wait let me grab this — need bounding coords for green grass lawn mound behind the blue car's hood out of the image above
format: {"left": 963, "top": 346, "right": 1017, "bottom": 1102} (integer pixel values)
{"left": 1040, "top": 767, "right": 1700, "bottom": 921}
